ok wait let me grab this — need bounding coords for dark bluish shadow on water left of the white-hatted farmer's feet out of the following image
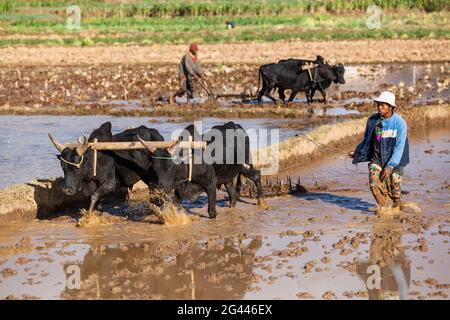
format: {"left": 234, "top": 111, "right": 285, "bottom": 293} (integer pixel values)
{"left": 296, "top": 192, "right": 373, "bottom": 213}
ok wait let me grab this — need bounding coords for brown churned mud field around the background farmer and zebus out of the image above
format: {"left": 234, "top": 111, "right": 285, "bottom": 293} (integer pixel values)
{"left": 0, "top": 62, "right": 450, "bottom": 118}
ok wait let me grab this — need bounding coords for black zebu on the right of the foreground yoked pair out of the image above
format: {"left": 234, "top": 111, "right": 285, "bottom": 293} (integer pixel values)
{"left": 139, "top": 122, "right": 262, "bottom": 217}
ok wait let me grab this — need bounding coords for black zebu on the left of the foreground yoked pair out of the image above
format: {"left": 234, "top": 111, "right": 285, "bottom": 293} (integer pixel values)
{"left": 49, "top": 122, "right": 164, "bottom": 211}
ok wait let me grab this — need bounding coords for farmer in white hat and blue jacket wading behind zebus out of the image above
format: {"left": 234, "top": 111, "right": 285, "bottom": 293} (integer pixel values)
{"left": 350, "top": 91, "right": 409, "bottom": 207}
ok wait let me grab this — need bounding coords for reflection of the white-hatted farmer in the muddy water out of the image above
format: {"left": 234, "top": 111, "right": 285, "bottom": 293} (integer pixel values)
{"left": 356, "top": 218, "right": 411, "bottom": 300}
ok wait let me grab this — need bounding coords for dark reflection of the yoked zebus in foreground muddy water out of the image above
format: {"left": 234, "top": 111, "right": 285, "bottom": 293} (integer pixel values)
{"left": 63, "top": 238, "right": 262, "bottom": 299}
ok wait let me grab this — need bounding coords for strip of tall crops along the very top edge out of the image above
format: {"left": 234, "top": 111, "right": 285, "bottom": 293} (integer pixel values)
{"left": 0, "top": 0, "right": 449, "bottom": 17}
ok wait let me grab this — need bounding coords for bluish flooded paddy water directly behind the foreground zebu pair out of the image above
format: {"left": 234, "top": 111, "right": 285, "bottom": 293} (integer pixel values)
{"left": 0, "top": 116, "right": 306, "bottom": 188}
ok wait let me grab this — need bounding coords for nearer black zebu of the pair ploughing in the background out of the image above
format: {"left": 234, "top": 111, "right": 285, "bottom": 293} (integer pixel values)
{"left": 258, "top": 56, "right": 337, "bottom": 103}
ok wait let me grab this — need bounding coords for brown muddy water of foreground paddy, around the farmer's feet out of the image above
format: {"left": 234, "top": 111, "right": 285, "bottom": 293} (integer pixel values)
{"left": 0, "top": 129, "right": 450, "bottom": 299}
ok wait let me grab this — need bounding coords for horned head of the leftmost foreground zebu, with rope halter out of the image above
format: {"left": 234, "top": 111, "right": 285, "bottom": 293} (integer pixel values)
{"left": 48, "top": 134, "right": 90, "bottom": 195}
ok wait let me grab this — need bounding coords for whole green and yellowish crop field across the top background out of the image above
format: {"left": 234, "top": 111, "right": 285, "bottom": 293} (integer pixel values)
{"left": 0, "top": 0, "right": 450, "bottom": 46}
